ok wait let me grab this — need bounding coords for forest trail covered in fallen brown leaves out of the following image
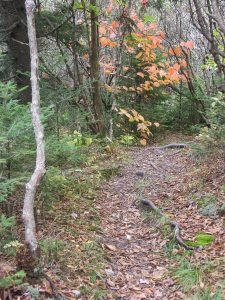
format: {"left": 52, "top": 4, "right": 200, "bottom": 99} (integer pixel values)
{"left": 97, "top": 142, "right": 224, "bottom": 300}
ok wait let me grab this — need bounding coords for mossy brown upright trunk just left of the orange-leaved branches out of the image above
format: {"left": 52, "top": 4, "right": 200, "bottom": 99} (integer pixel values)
{"left": 90, "top": 0, "right": 106, "bottom": 134}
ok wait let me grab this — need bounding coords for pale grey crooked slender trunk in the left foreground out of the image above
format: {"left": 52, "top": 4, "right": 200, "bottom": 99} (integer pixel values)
{"left": 23, "top": 0, "right": 45, "bottom": 258}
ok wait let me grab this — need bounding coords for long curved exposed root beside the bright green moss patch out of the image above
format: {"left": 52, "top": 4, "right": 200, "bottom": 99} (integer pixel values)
{"left": 141, "top": 199, "right": 196, "bottom": 250}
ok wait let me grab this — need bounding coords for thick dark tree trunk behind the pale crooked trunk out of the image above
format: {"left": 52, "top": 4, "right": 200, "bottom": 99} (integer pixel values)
{"left": 0, "top": 0, "right": 31, "bottom": 103}
